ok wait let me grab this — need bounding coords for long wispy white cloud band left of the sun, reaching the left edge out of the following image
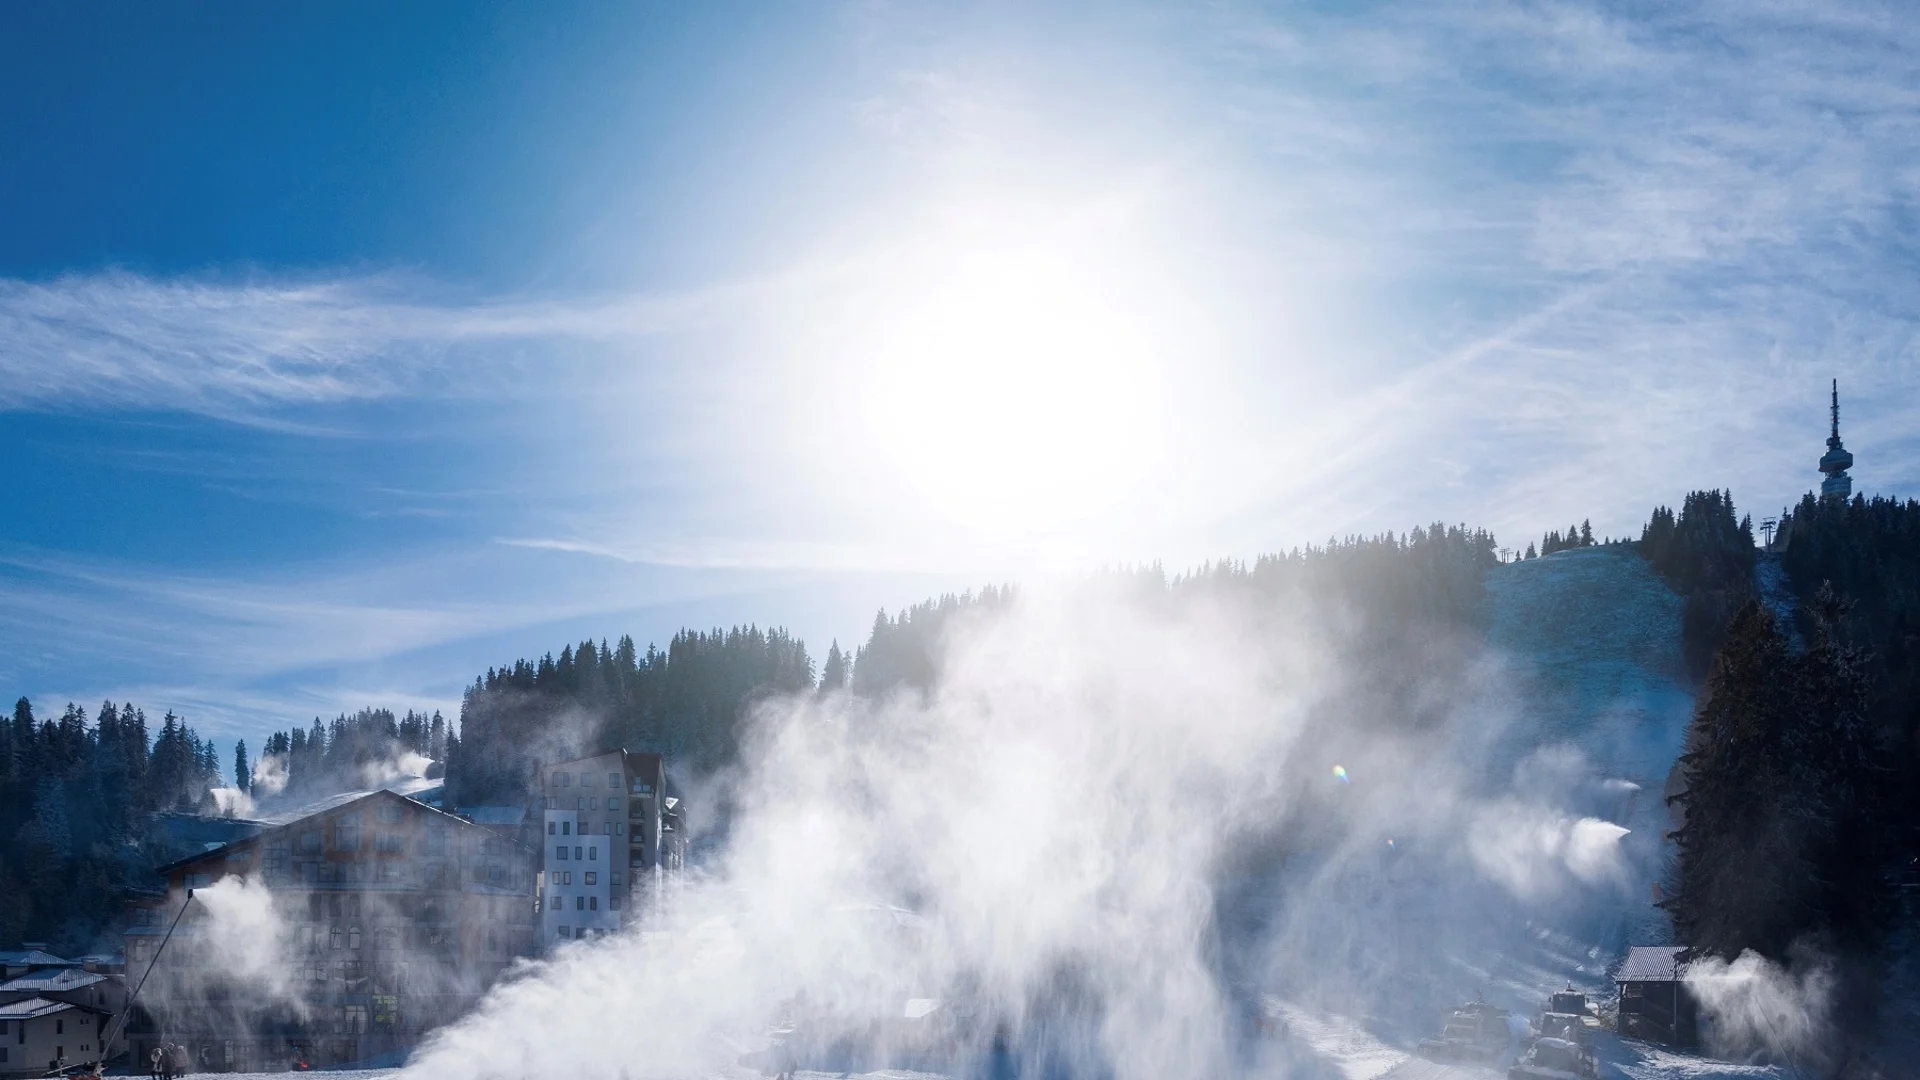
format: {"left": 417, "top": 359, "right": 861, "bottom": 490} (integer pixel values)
{"left": 0, "top": 271, "right": 739, "bottom": 419}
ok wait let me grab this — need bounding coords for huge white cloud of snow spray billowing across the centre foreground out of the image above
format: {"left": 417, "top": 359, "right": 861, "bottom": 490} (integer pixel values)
{"left": 409, "top": 576, "right": 1624, "bottom": 1080}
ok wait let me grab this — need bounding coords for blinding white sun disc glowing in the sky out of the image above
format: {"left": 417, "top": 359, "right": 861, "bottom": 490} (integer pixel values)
{"left": 862, "top": 237, "right": 1158, "bottom": 540}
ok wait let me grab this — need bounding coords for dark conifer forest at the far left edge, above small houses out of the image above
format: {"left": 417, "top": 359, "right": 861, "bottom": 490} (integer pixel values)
{"left": 0, "top": 698, "right": 223, "bottom": 947}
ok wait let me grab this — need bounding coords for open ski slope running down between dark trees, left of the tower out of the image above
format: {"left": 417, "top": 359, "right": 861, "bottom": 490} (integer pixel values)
{"left": 1283, "top": 548, "right": 1728, "bottom": 1080}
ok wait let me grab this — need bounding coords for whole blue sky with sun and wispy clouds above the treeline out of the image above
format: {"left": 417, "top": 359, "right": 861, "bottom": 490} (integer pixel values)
{"left": 0, "top": 2, "right": 1920, "bottom": 738}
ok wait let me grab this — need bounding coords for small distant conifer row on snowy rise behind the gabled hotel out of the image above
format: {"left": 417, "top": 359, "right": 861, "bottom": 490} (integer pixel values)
{"left": 253, "top": 709, "right": 459, "bottom": 798}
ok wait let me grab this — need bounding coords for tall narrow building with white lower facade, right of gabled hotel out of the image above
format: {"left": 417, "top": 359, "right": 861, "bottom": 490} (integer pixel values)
{"left": 538, "top": 749, "right": 685, "bottom": 947}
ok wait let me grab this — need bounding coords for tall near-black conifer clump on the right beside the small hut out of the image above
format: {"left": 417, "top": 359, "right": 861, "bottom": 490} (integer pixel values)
{"left": 1667, "top": 590, "right": 1891, "bottom": 963}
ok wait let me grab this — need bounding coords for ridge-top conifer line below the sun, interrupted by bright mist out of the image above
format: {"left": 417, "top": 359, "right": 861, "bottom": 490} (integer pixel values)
{"left": 447, "top": 525, "right": 1500, "bottom": 805}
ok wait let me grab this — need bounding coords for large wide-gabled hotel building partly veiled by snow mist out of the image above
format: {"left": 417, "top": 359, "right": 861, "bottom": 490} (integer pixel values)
{"left": 125, "top": 780, "right": 538, "bottom": 1070}
